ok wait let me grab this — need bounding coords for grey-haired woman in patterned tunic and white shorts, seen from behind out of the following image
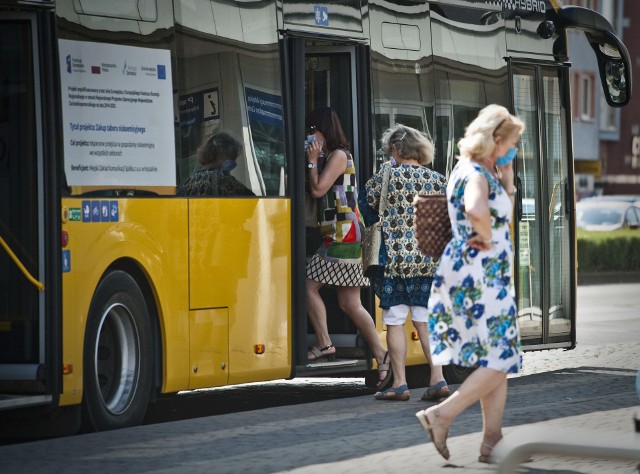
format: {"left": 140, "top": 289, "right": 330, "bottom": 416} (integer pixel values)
{"left": 360, "top": 124, "right": 449, "bottom": 401}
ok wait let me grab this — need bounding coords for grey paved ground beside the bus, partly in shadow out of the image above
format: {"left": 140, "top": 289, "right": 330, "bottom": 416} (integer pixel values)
{"left": 0, "top": 284, "right": 640, "bottom": 474}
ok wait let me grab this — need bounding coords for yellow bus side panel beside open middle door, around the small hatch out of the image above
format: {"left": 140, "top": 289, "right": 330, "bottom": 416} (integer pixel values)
{"left": 189, "top": 199, "right": 291, "bottom": 383}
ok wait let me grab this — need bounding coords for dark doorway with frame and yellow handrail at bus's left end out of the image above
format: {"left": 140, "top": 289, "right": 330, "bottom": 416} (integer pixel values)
{"left": 0, "top": 5, "right": 69, "bottom": 434}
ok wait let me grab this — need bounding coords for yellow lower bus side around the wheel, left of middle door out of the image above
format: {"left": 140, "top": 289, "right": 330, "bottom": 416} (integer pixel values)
{"left": 62, "top": 199, "right": 291, "bottom": 404}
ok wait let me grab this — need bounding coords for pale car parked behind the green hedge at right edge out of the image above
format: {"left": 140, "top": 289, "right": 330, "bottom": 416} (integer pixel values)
{"left": 576, "top": 198, "right": 640, "bottom": 231}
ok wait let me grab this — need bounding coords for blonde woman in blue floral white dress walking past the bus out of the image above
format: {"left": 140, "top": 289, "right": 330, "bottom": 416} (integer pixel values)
{"left": 416, "top": 105, "right": 524, "bottom": 462}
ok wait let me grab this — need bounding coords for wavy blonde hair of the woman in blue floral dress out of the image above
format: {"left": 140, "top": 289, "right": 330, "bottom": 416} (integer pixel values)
{"left": 458, "top": 104, "right": 524, "bottom": 160}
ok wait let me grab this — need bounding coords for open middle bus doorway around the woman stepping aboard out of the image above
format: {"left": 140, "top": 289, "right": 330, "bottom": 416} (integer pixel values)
{"left": 285, "top": 34, "right": 374, "bottom": 374}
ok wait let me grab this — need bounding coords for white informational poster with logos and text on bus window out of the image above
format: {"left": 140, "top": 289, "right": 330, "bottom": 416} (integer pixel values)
{"left": 59, "top": 40, "right": 176, "bottom": 187}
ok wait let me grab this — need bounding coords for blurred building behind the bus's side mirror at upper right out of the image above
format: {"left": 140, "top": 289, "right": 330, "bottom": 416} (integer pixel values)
{"left": 564, "top": 0, "right": 640, "bottom": 198}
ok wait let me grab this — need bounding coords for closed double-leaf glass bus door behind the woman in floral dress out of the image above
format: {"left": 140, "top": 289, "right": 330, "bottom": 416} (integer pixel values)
{"left": 512, "top": 64, "right": 576, "bottom": 349}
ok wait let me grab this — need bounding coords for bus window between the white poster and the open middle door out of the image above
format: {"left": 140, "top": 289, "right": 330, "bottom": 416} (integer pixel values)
{"left": 176, "top": 6, "right": 287, "bottom": 196}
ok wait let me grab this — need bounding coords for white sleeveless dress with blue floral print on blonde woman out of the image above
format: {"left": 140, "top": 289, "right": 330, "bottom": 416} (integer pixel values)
{"left": 429, "top": 158, "right": 522, "bottom": 373}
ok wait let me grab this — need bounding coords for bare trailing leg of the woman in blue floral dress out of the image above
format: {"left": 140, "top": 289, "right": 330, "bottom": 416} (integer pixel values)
{"left": 416, "top": 367, "right": 507, "bottom": 459}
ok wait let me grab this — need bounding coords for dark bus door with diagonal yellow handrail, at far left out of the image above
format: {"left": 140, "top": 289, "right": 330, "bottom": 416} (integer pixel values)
{"left": 0, "top": 9, "right": 59, "bottom": 413}
